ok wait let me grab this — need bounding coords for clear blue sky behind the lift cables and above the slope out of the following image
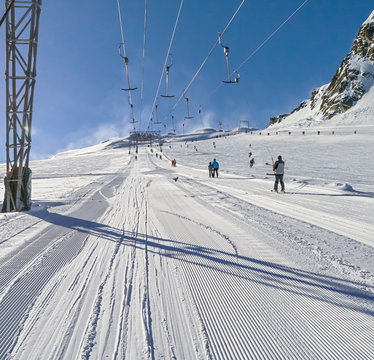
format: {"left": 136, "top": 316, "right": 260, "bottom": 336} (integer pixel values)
{"left": 0, "top": 0, "right": 373, "bottom": 162}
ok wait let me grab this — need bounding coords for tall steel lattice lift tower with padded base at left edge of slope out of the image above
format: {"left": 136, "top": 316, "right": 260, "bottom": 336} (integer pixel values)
{"left": 2, "top": 0, "right": 42, "bottom": 212}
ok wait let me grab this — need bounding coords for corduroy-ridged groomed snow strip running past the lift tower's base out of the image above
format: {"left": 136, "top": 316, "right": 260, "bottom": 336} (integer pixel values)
{"left": 0, "top": 170, "right": 130, "bottom": 359}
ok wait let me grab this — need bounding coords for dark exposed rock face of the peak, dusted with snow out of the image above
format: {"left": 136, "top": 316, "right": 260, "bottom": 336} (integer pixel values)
{"left": 270, "top": 11, "right": 374, "bottom": 125}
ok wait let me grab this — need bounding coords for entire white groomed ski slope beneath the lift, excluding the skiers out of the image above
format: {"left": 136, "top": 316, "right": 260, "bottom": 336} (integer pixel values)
{"left": 0, "top": 127, "right": 374, "bottom": 360}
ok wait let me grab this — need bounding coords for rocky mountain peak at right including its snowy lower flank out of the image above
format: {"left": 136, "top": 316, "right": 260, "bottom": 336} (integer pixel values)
{"left": 270, "top": 11, "right": 374, "bottom": 126}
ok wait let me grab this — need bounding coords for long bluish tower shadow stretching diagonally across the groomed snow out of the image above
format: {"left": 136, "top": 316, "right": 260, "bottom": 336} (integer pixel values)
{"left": 30, "top": 210, "right": 374, "bottom": 316}
